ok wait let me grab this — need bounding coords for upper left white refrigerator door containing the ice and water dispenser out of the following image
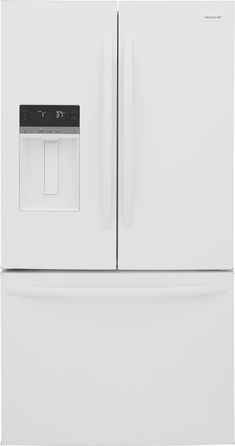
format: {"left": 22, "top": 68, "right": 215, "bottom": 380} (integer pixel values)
{"left": 2, "top": 0, "right": 117, "bottom": 269}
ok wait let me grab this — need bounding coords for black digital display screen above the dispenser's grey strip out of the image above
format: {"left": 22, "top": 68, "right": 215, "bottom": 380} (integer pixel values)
{"left": 20, "top": 105, "right": 80, "bottom": 127}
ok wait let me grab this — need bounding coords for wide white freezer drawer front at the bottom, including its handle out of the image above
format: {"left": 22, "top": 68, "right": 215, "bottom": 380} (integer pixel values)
{"left": 2, "top": 272, "right": 234, "bottom": 446}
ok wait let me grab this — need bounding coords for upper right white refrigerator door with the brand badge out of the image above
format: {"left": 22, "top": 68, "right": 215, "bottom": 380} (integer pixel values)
{"left": 118, "top": 1, "right": 234, "bottom": 270}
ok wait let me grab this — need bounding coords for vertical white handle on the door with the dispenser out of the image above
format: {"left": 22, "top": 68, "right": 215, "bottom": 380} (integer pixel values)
{"left": 101, "top": 41, "right": 114, "bottom": 229}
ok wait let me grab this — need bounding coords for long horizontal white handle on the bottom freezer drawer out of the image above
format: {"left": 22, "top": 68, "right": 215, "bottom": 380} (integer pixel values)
{"left": 7, "top": 285, "right": 227, "bottom": 300}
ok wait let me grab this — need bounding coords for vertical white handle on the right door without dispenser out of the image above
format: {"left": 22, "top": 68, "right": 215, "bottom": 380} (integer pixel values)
{"left": 121, "top": 40, "right": 134, "bottom": 228}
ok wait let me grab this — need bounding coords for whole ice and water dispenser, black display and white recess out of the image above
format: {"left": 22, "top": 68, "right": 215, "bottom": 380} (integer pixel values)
{"left": 20, "top": 105, "right": 80, "bottom": 211}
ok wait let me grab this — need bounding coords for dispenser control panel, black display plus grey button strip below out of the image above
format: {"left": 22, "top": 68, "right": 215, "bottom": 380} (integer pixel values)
{"left": 20, "top": 105, "right": 80, "bottom": 133}
